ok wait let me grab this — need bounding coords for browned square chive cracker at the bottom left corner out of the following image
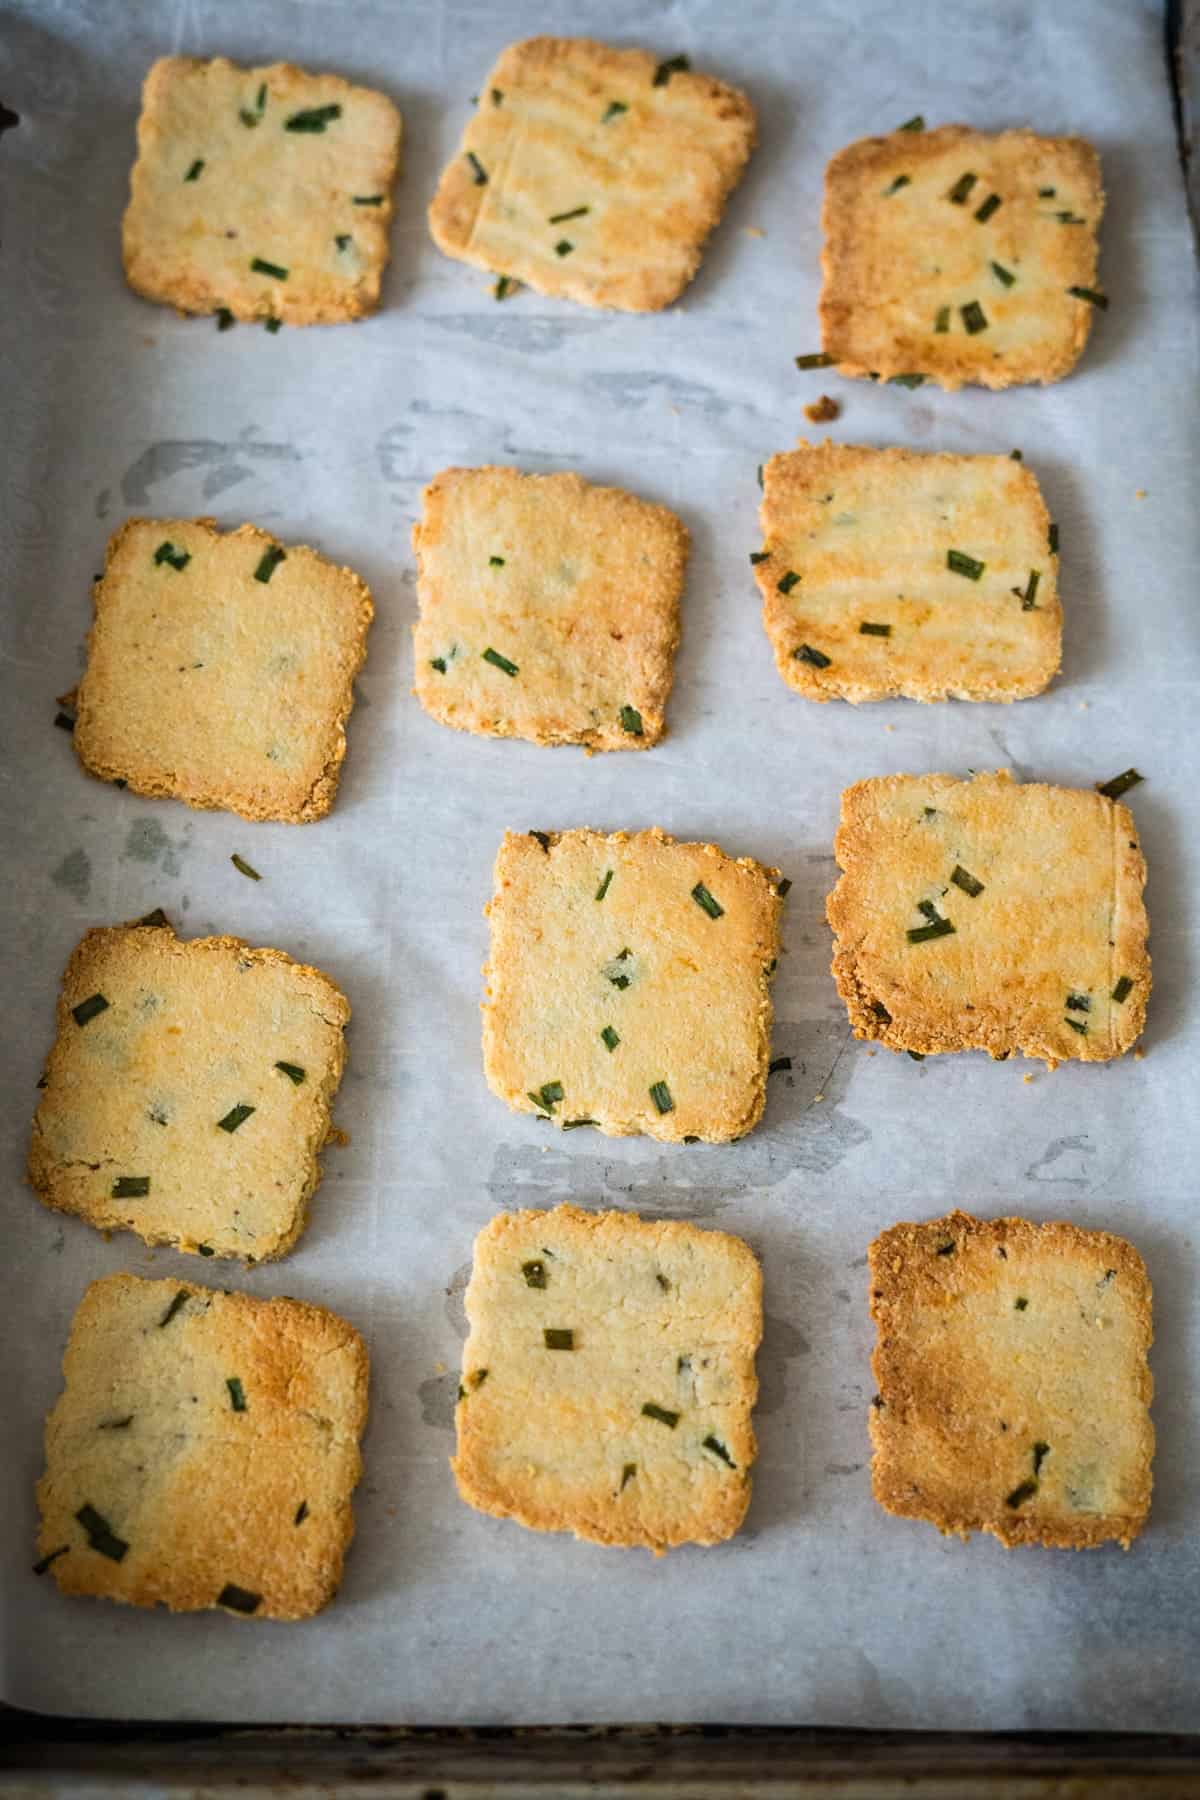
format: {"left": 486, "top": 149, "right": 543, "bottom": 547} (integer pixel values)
{"left": 38, "top": 1274, "right": 367, "bottom": 1618}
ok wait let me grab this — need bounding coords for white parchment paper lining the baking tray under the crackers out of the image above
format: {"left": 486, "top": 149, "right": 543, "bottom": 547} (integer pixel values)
{"left": 0, "top": 0, "right": 1200, "bottom": 1728}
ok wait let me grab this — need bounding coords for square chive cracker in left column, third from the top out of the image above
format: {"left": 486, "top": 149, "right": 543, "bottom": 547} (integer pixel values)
{"left": 29, "top": 925, "right": 351, "bottom": 1262}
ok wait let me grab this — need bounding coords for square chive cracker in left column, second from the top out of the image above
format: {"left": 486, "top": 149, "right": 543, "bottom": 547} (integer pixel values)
{"left": 74, "top": 518, "right": 374, "bottom": 824}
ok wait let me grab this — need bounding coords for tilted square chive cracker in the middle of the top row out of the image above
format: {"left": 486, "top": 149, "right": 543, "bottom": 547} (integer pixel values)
{"left": 430, "top": 38, "right": 756, "bottom": 313}
